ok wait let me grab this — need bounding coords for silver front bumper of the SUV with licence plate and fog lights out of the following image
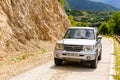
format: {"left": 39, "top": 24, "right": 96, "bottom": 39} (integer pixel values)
{"left": 54, "top": 50, "right": 97, "bottom": 61}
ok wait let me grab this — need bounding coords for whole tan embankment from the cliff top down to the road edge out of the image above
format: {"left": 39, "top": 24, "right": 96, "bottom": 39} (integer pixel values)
{"left": 0, "top": 0, "right": 70, "bottom": 80}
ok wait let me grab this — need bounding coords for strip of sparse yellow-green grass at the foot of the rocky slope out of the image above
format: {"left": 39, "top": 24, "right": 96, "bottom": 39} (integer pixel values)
{"left": 10, "top": 48, "right": 47, "bottom": 62}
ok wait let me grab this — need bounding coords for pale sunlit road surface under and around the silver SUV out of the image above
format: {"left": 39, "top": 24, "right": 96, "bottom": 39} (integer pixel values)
{"left": 11, "top": 38, "right": 113, "bottom": 80}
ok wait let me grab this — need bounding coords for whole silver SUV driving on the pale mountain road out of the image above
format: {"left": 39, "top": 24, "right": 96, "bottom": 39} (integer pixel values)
{"left": 54, "top": 27, "right": 102, "bottom": 68}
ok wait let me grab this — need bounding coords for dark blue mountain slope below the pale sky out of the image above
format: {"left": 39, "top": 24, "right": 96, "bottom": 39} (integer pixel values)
{"left": 67, "top": 0, "right": 118, "bottom": 11}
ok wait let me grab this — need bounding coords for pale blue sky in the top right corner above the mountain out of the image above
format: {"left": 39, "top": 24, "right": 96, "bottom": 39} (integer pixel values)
{"left": 91, "top": 0, "right": 120, "bottom": 8}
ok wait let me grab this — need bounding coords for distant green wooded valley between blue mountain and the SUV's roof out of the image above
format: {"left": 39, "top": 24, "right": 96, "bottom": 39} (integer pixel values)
{"left": 67, "top": 10, "right": 113, "bottom": 27}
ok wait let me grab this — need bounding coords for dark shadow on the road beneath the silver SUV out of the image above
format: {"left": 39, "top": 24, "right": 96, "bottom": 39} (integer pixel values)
{"left": 50, "top": 62, "right": 95, "bottom": 72}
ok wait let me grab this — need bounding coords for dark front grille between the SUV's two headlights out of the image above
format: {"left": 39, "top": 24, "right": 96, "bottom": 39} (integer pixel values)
{"left": 64, "top": 45, "right": 83, "bottom": 52}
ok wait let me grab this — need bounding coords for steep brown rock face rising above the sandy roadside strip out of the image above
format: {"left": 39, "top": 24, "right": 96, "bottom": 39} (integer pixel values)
{"left": 0, "top": 0, "right": 70, "bottom": 50}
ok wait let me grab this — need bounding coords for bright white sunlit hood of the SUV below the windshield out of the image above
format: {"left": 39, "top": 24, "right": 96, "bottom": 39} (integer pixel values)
{"left": 58, "top": 39, "right": 96, "bottom": 45}
